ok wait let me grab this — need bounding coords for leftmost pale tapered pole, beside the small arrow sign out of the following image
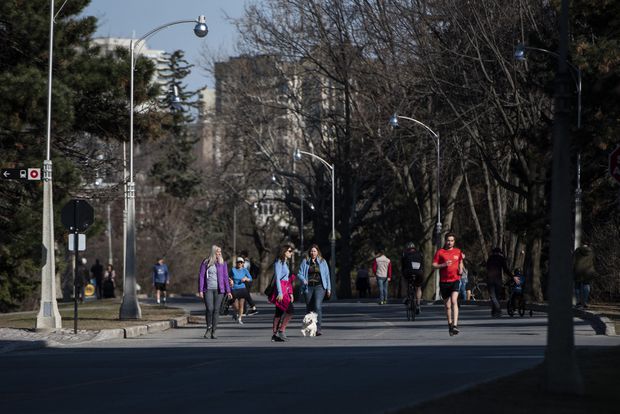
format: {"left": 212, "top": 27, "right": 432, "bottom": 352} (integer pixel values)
{"left": 35, "top": 0, "right": 62, "bottom": 330}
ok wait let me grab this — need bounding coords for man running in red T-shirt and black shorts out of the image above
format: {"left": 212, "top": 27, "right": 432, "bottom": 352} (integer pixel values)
{"left": 433, "top": 233, "right": 463, "bottom": 336}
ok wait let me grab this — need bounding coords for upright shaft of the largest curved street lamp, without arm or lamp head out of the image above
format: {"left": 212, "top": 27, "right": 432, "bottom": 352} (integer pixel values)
{"left": 119, "top": 39, "right": 142, "bottom": 320}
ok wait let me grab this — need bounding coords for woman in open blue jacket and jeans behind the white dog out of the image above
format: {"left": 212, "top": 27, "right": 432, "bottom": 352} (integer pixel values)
{"left": 299, "top": 244, "right": 332, "bottom": 336}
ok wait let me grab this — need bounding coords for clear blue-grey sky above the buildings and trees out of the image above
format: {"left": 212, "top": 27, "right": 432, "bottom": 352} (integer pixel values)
{"left": 81, "top": 0, "right": 253, "bottom": 90}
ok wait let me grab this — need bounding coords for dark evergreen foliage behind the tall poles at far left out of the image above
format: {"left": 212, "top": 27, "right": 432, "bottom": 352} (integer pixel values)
{"left": 0, "top": 0, "right": 162, "bottom": 312}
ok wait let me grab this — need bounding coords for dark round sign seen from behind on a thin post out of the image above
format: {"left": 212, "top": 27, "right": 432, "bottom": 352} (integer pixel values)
{"left": 60, "top": 200, "right": 95, "bottom": 333}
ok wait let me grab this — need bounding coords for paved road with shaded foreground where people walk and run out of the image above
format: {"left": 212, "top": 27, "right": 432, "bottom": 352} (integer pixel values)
{"left": 0, "top": 299, "right": 620, "bottom": 414}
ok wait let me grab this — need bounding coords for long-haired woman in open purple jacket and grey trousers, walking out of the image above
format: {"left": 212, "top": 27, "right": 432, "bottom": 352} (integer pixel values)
{"left": 198, "top": 245, "right": 232, "bottom": 339}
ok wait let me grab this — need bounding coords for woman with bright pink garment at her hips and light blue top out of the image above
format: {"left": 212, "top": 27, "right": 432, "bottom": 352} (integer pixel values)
{"left": 271, "top": 245, "right": 294, "bottom": 342}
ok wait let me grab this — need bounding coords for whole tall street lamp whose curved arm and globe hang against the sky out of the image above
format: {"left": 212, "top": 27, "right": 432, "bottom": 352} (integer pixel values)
{"left": 120, "top": 16, "right": 209, "bottom": 320}
